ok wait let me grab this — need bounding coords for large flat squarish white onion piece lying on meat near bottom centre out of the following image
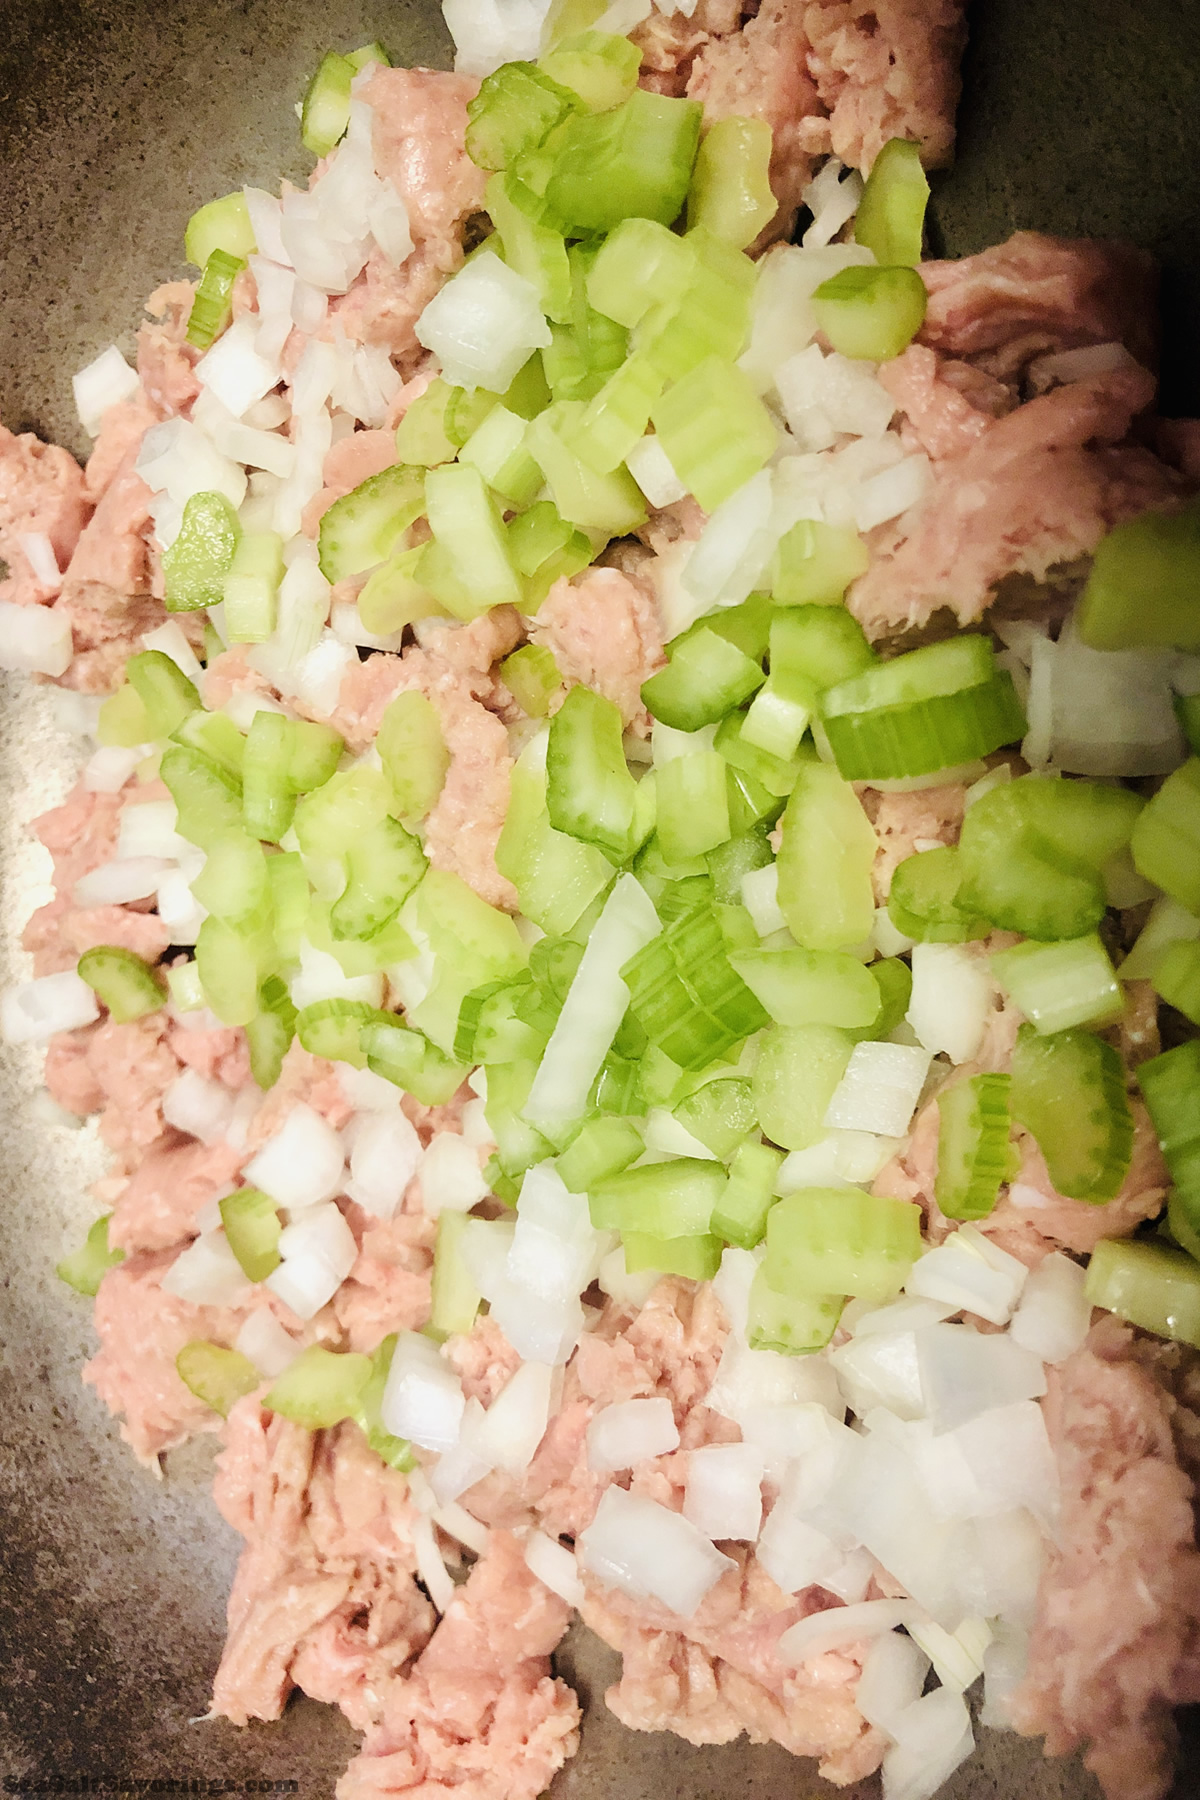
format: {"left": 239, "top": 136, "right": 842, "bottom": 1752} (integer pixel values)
{"left": 579, "top": 1487, "right": 738, "bottom": 1618}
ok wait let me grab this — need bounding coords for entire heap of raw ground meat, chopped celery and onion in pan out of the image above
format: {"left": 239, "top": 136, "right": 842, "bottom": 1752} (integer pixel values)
{"left": 0, "top": 10, "right": 1200, "bottom": 1800}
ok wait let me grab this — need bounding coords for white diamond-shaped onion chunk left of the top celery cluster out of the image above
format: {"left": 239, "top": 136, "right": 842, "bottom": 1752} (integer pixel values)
{"left": 416, "top": 250, "right": 551, "bottom": 394}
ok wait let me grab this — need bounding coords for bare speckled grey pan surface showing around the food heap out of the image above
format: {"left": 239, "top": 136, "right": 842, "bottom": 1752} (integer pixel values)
{"left": 0, "top": 0, "right": 1200, "bottom": 1800}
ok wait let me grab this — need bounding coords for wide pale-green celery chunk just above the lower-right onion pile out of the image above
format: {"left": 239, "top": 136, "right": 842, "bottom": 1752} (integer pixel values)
{"left": 763, "top": 1188, "right": 921, "bottom": 1305}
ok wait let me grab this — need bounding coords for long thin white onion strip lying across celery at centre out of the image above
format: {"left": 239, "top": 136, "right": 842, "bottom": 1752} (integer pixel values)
{"left": 521, "top": 874, "right": 662, "bottom": 1134}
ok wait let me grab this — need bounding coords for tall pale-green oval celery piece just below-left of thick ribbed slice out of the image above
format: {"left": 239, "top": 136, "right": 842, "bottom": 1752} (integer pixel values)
{"left": 779, "top": 763, "right": 876, "bottom": 950}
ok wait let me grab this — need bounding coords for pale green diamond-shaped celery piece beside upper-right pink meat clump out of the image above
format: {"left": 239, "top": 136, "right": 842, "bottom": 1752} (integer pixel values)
{"left": 649, "top": 356, "right": 779, "bottom": 513}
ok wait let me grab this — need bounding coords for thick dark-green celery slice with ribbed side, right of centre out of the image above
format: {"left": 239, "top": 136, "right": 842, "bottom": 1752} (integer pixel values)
{"left": 822, "top": 635, "right": 1025, "bottom": 781}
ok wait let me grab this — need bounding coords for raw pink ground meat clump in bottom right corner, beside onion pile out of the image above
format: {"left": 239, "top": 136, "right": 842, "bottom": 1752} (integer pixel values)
{"left": 1013, "top": 1318, "right": 1200, "bottom": 1800}
